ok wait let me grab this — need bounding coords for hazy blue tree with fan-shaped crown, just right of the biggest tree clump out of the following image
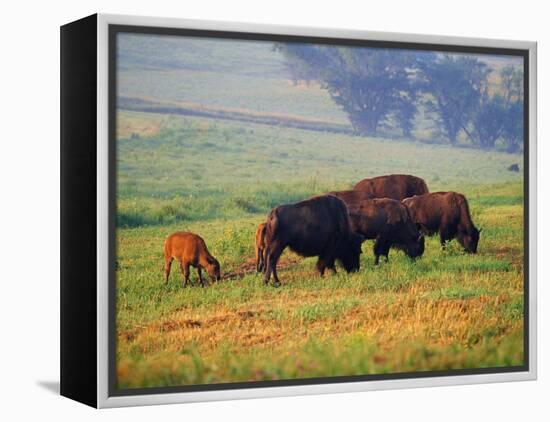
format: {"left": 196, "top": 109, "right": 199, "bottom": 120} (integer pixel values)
{"left": 421, "top": 54, "right": 490, "bottom": 145}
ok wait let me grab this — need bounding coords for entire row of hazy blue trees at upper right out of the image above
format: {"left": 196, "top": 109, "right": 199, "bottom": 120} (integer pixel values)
{"left": 276, "top": 43, "right": 523, "bottom": 152}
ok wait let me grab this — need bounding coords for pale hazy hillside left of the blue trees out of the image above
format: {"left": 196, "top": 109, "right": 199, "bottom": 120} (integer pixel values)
{"left": 118, "top": 34, "right": 349, "bottom": 125}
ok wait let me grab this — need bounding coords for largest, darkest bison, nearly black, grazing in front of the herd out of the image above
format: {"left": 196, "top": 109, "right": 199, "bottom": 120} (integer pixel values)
{"left": 264, "top": 195, "right": 363, "bottom": 286}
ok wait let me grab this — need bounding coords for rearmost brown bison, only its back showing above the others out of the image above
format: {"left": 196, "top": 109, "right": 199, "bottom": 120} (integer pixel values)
{"left": 353, "top": 174, "right": 428, "bottom": 201}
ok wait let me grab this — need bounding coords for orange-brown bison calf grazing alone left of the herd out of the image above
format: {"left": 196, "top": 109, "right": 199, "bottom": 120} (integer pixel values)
{"left": 164, "top": 232, "right": 221, "bottom": 287}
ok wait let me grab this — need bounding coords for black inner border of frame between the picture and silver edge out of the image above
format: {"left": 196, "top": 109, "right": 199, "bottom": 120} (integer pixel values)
{"left": 108, "top": 25, "right": 529, "bottom": 397}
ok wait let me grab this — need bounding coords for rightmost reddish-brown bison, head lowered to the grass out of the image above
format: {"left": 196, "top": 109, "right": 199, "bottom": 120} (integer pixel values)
{"left": 403, "top": 192, "right": 481, "bottom": 253}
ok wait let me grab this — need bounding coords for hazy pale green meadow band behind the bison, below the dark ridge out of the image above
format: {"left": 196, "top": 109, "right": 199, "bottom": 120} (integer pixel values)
{"left": 117, "top": 112, "right": 523, "bottom": 227}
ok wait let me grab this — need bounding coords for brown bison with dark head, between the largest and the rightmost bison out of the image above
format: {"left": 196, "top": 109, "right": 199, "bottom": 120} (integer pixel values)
{"left": 348, "top": 198, "right": 424, "bottom": 265}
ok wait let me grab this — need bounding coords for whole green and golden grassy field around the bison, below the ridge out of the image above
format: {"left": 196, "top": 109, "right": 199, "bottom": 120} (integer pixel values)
{"left": 116, "top": 112, "right": 523, "bottom": 388}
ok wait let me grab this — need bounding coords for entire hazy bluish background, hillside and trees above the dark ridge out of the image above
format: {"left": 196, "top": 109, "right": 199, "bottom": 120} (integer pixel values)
{"left": 118, "top": 34, "right": 523, "bottom": 152}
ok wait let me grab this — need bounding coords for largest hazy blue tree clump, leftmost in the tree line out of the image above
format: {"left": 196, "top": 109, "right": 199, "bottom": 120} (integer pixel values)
{"left": 278, "top": 44, "right": 418, "bottom": 136}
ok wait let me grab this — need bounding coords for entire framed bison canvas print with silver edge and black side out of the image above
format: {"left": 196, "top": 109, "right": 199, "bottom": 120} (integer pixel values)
{"left": 61, "top": 15, "right": 536, "bottom": 407}
